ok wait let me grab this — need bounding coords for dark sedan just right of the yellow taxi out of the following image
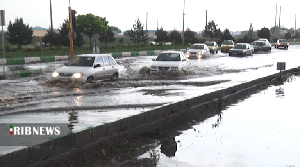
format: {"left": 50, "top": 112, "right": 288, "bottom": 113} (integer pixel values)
{"left": 228, "top": 43, "right": 254, "bottom": 56}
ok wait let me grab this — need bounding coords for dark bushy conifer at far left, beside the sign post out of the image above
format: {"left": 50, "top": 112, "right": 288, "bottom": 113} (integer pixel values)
{"left": 6, "top": 18, "right": 33, "bottom": 46}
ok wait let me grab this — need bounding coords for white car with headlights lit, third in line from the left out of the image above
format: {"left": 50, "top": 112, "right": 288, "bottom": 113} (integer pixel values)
{"left": 186, "top": 43, "right": 210, "bottom": 59}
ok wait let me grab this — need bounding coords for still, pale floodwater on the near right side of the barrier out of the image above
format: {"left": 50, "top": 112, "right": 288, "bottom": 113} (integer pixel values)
{"left": 138, "top": 76, "right": 300, "bottom": 167}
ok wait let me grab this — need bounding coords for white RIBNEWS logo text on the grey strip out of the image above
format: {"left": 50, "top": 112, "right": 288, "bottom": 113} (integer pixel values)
{"left": 10, "top": 125, "right": 60, "bottom": 136}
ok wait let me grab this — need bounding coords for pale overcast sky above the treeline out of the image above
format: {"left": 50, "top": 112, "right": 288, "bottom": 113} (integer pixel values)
{"left": 0, "top": 0, "right": 300, "bottom": 32}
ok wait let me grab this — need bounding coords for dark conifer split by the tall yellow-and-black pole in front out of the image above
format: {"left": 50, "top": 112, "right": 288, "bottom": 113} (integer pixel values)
{"left": 58, "top": 20, "right": 85, "bottom": 47}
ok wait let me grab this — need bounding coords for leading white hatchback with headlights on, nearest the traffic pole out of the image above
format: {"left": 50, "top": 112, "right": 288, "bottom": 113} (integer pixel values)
{"left": 52, "top": 54, "right": 119, "bottom": 82}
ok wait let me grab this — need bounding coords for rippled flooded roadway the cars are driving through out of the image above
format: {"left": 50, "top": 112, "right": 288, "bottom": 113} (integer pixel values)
{"left": 0, "top": 45, "right": 300, "bottom": 157}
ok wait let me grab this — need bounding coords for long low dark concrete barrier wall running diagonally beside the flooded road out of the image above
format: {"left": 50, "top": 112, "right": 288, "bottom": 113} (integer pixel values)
{"left": 0, "top": 69, "right": 295, "bottom": 167}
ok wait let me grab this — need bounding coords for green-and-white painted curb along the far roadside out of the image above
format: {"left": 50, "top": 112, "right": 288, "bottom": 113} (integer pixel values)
{"left": 0, "top": 49, "right": 186, "bottom": 65}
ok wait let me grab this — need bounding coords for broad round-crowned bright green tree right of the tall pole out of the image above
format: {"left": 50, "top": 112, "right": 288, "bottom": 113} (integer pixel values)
{"left": 76, "top": 13, "right": 108, "bottom": 47}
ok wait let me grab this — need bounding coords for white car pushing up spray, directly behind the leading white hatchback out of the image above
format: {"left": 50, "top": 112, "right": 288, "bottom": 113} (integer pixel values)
{"left": 150, "top": 51, "right": 187, "bottom": 74}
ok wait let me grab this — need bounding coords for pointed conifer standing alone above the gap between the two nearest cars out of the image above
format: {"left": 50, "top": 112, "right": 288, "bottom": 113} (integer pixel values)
{"left": 129, "top": 18, "right": 149, "bottom": 45}
